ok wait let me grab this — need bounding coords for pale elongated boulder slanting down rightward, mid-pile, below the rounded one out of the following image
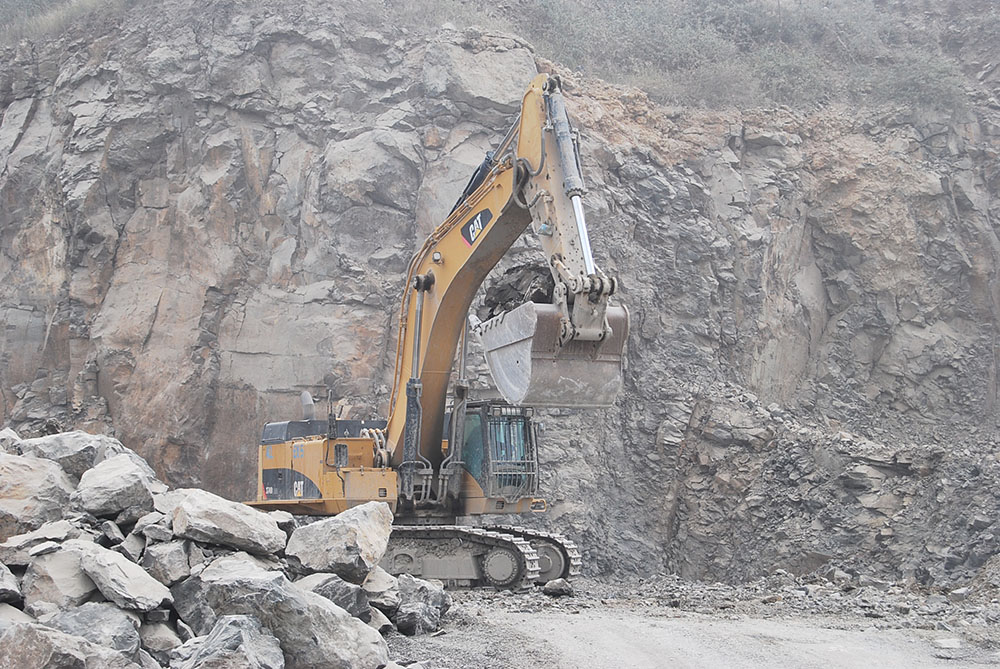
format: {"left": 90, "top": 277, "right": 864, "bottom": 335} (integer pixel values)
{"left": 64, "top": 539, "right": 173, "bottom": 611}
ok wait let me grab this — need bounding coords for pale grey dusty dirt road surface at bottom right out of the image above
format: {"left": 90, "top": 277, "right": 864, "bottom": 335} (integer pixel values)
{"left": 389, "top": 597, "right": 1000, "bottom": 669}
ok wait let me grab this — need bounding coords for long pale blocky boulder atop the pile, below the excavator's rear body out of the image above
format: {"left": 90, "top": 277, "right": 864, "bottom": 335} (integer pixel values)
{"left": 173, "top": 489, "right": 285, "bottom": 555}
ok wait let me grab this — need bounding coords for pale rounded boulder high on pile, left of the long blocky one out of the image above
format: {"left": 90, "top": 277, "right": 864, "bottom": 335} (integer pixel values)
{"left": 73, "top": 453, "right": 155, "bottom": 516}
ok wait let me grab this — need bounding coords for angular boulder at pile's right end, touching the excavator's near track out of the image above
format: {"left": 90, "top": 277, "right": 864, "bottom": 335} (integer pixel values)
{"left": 285, "top": 502, "right": 392, "bottom": 583}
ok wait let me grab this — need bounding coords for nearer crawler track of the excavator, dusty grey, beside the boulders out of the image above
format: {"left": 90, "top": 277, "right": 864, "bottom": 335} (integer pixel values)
{"left": 381, "top": 525, "right": 541, "bottom": 590}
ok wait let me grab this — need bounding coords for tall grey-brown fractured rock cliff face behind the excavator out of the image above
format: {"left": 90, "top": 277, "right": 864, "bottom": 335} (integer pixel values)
{"left": 0, "top": 0, "right": 1000, "bottom": 582}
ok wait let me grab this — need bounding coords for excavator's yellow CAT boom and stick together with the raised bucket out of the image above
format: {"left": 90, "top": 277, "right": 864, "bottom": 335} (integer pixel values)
{"left": 387, "top": 74, "right": 628, "bottom": 498}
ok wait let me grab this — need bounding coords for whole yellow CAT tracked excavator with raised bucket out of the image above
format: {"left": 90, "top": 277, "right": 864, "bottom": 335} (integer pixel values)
{"left": 250, "top": 74, "right": 629, "bottom": 589}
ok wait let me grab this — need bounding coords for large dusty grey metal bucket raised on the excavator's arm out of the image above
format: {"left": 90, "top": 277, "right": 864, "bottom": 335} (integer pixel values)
{"left": 476, "top": 302, "right": 628, "bottom": 408}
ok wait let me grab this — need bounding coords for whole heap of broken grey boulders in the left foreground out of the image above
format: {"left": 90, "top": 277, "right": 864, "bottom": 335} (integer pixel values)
{"left": 0, "top": 429, "right": 451, "bottom": 669}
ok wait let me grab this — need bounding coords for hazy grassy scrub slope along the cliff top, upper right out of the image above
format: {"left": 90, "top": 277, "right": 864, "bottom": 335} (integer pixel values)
{"left": 382, "top": 0, "right": 976, "bottom": 108}
